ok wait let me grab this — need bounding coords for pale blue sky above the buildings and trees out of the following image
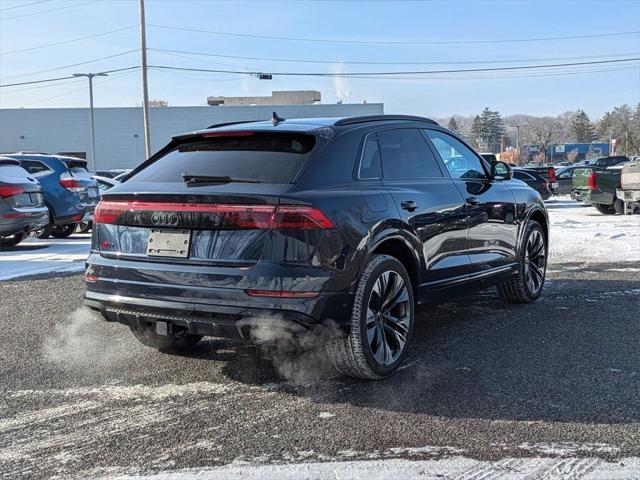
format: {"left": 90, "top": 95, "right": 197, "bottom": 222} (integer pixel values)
{"left": 0, "top": 0, "right": 640, "bottom": 118}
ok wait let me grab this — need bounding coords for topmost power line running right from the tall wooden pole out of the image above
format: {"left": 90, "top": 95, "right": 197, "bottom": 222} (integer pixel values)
{"left": 147, "top": 23, "right": 640, "bottom": 45}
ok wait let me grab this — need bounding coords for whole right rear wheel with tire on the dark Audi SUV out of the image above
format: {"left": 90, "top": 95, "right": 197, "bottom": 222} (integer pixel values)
{"left": 327, "top": 255, "right": 414, "bottom": 380}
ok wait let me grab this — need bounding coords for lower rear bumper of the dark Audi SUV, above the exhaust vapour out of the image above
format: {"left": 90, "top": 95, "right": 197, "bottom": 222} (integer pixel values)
{"left": 84, "top": 290, "right": 351, "bottom": 342}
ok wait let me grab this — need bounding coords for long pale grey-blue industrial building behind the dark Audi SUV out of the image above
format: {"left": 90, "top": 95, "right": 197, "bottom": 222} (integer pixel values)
{"left": 0, "top": 103, "right": 384, "bottom": 169}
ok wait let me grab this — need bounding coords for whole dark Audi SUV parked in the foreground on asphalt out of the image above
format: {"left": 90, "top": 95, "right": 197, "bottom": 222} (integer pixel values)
{"left": 85, "top": 115, "right": 549, "bottom": 379}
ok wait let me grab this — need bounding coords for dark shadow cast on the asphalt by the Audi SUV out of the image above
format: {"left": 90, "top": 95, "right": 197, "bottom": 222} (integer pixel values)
{"left": 214, "top": 279, "right": 640, "bottom": 423}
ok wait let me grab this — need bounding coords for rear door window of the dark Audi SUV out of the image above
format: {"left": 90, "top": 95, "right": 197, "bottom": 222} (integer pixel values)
{"left": 378, "top": 128, "right": 442, "bottom": 180}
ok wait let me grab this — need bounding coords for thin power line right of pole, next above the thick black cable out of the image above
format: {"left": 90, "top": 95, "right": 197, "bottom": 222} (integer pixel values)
{"left": 149, "top": 48, "right": 638, "bottom": 67}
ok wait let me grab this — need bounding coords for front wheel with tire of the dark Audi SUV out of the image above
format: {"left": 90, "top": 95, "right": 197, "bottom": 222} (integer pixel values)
{"left": 498, "top": 220, "right": 547, "bottom": 303}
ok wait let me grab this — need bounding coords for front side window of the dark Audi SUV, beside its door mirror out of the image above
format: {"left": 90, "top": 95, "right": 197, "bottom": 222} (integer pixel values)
{"left": 425, "top": 130, "right": 486, "bottom": 178}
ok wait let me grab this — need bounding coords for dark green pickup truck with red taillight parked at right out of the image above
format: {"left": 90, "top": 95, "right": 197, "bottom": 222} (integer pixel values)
{"left": 573, "top": 164, "right": 625, "bottom": 215}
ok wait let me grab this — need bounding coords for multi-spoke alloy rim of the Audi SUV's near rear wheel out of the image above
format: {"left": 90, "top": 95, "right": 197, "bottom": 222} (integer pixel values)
{"left": 366, "top": 270, "right": 411, "bottom": 367}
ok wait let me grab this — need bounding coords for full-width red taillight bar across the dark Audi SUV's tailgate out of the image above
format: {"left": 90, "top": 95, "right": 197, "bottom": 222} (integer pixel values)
{"left": 93, "top": 201, "right": 334, "bottom": 230}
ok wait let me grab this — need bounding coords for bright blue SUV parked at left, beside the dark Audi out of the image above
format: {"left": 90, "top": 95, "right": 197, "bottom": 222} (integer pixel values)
{"left": 7, "top": 153, "right": 98, "bottom": 238}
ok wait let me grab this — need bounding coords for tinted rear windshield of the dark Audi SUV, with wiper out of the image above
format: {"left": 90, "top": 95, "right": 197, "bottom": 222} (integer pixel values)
{"left": 128, "top": 132, "right": 315, "bottom": 183}
